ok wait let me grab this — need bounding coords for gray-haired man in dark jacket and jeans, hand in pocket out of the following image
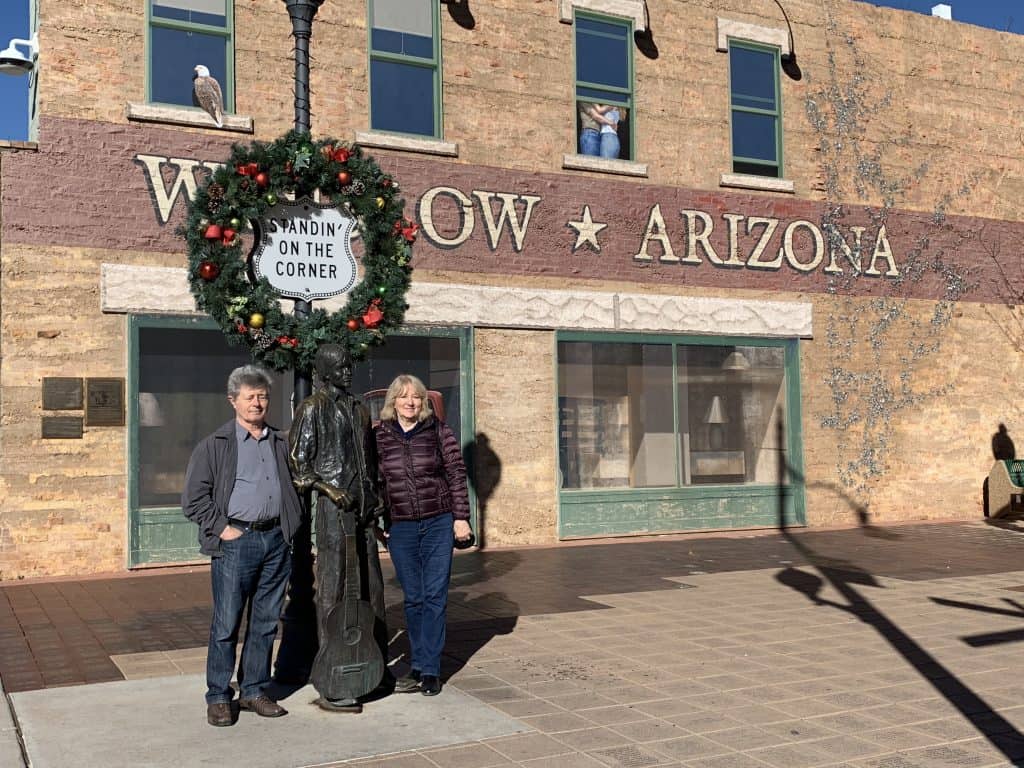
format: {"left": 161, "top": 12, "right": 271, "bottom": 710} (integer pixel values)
{"left": 181, "top": 366, "right": 302, "bottom": 726}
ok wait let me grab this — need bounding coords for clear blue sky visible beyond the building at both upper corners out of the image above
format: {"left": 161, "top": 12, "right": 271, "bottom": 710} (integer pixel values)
{"left": 0, "top": 0, "right": 1024, "bottom": 141}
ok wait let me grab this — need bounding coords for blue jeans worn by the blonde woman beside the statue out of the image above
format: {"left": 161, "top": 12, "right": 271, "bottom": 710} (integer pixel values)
{"left": 387, "top": 514, "right": 455, "bottom": 676}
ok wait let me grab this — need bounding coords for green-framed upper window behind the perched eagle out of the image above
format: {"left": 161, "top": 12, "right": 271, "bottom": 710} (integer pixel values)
{"left": 147, "top": 0, "right": 234, "bottom": 113}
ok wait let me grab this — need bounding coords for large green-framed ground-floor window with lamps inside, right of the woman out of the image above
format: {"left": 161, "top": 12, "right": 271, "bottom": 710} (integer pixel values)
{"left": 554, "top": 331, "right": 806, "bottom": 539}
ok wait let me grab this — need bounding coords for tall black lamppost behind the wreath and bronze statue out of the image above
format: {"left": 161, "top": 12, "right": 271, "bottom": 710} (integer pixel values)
{"left": 274, "top": 0, "right": 325, "bottom": 685}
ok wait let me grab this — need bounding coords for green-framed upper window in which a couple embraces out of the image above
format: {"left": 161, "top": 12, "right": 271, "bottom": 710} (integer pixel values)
{"left": 572, "top": 9, "right": 636, "bottom": 160}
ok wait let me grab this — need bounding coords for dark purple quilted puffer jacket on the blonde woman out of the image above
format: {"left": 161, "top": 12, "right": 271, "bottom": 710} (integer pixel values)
{"left": 374, "top": 417, "right": 469, "bottom": 522}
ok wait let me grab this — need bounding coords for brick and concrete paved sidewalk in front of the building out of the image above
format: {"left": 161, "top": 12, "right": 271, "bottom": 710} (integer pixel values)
{"left": 6, "top": 521, "right": 1024, "bottom": 768}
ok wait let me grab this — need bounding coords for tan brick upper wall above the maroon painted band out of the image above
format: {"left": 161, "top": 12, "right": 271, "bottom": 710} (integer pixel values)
{"left": 39, "top": 0, "right": 1024, "bottom": 218}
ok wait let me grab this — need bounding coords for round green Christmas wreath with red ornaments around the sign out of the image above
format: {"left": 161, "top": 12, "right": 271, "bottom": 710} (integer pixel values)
{"left": 179, "top": 131, "right": 418, "bottom": 371}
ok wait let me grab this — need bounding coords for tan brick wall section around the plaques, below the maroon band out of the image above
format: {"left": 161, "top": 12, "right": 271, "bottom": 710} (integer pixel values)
{"left": 0, "top": 246, "right": 140, "bottom": 579}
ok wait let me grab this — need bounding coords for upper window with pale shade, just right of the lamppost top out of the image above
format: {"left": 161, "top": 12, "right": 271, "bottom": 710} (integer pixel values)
{"left": 370, "top": 0, "right": 441, "bottom": 138}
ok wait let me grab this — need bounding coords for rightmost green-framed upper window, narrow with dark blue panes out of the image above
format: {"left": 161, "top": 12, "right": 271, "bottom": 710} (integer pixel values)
{"left": 729, "top": 40, "right": 782, "bottom": 178}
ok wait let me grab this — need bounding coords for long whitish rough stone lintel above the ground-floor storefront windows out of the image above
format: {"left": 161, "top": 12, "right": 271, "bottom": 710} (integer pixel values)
{"left": 99, "top": 264, "right": 813, "bottom": 338}
